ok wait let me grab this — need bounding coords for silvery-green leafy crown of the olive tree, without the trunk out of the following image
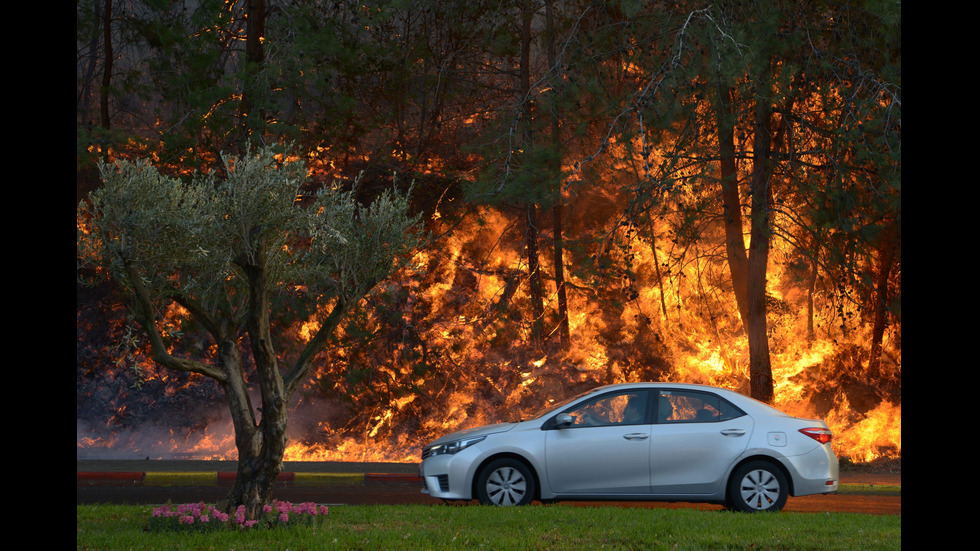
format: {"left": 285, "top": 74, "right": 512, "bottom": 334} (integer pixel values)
{"left": 77, "top": 144, "right": 419, "bottom": 328}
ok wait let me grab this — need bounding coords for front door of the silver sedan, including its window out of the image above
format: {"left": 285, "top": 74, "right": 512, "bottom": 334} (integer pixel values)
{"left": 545, "top": 390, "right": 652, "bottom": 496}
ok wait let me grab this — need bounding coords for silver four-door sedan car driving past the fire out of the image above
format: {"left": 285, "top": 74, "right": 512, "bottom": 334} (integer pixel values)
{"left": 420, "top": 383, "right": 838, "bottom": 511}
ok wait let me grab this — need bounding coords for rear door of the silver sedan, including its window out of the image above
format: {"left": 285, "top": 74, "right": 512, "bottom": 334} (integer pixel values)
{"left": 650, "top": 390, "right": 753, "bottom": 495}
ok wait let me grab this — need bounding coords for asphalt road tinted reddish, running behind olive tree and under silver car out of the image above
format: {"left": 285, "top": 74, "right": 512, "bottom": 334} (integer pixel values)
{"left": 76, "top": 460, "right": 902, "bottom": 515}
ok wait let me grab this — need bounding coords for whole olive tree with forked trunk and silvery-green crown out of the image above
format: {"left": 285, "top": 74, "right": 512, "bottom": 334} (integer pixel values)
{"left": 77, "top": 148, "right": 421, "bottom": 516}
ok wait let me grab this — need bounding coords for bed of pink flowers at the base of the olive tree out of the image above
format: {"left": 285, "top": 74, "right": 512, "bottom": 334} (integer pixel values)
{"left": 147, "top": 500, "right": 327, "bottom": 531}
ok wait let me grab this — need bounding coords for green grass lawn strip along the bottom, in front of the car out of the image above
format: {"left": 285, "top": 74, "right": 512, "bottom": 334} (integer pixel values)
{"left": 76, "top": 504, "right": 902, "bottom": 551}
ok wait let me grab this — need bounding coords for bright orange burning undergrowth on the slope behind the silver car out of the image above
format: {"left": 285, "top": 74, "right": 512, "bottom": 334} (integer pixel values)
{"left": 76, "top": 167, "right": 901, "bottom": 462}
